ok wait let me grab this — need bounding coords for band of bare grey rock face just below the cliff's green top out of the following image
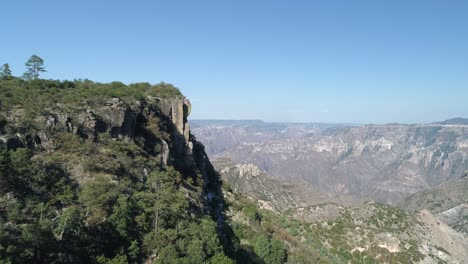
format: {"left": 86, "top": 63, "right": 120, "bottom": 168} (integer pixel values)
{"left": 0, "top": 97, "right": 195, "bottom": 173}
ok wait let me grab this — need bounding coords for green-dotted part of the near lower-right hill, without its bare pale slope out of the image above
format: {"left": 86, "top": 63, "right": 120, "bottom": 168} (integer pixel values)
{"left": 229, "top": 191, "right": 424, "bottom": 264}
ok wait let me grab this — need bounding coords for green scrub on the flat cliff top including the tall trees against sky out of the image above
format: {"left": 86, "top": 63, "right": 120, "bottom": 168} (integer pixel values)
{"left": 0, "top": 55, "right": 183, "bottom": 124}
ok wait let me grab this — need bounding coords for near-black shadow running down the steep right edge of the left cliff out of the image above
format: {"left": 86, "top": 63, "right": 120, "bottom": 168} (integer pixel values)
{"left": 135, "top": 103, "right": 250, "bottom": 263}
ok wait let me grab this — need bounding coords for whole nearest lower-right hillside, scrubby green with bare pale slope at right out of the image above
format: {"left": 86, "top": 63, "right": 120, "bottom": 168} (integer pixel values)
{"left": 225, "top": 186, "right": 468, "bottom": 264}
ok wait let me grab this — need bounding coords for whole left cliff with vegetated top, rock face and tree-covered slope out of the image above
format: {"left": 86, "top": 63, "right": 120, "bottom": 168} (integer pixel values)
{"left": 0, "top": 78, "right": 236, "bottom": 263}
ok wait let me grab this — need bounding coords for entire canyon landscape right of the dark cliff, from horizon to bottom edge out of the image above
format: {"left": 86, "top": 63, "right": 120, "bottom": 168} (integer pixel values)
{"left": 192, "top": 120, "right": 468, "bottom": 263}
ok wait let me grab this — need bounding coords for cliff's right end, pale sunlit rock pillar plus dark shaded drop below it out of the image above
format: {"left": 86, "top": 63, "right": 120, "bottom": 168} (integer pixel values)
{"left": 78, "top": 97, "right": 263, "bottom": 263}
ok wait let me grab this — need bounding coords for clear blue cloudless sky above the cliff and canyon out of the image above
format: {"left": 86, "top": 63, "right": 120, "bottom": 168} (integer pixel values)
{"left": 0, "top": 0, "right": 468, "bottom": 123}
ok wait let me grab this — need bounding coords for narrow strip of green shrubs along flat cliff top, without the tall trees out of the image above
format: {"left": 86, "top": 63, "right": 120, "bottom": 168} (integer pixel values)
{"left": 0, "top": 77, "right": 182, "bottom": 110}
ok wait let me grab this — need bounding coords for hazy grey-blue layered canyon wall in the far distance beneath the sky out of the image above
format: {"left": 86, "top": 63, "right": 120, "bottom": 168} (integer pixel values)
{"left": 193, "top": 121, "right": 468, "bottom": 204}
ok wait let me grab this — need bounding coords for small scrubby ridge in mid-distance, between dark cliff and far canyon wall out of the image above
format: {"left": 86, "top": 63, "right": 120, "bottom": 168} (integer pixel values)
{"left": 213, "top": 159, "right": 363, "bottom": 221}
